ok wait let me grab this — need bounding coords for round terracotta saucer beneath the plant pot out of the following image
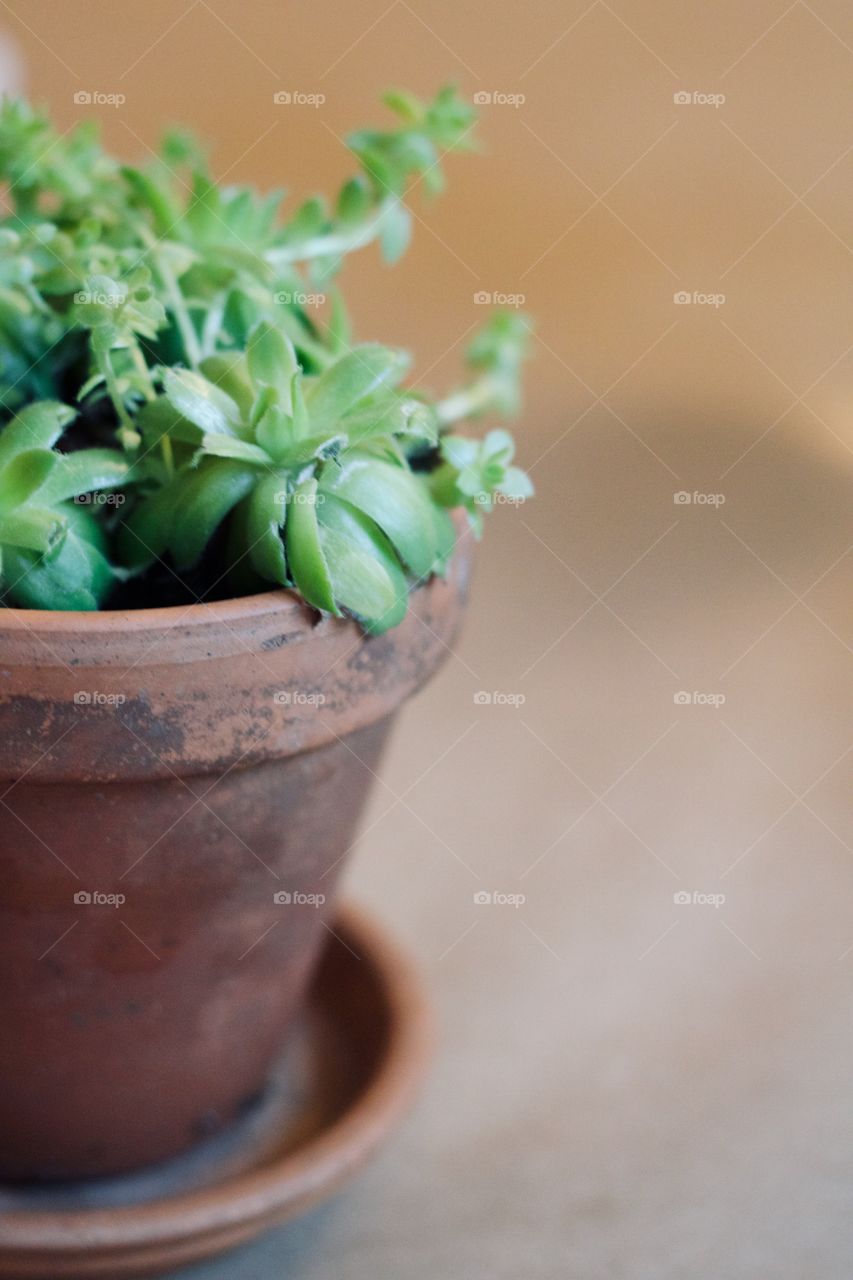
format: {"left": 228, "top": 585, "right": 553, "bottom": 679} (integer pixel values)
{"left": 0, "top": 908, "right": 429, "bottom": 1280}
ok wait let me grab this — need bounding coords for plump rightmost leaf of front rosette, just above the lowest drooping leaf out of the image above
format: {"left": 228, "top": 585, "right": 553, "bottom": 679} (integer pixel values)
{"left": 321, "top": 454, "right": 438, "bottom": 577}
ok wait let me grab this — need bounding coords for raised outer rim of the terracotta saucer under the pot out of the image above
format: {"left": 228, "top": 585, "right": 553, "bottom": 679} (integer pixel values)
{"left": 0, "top": 902, "right": 434, "bottom": 1259}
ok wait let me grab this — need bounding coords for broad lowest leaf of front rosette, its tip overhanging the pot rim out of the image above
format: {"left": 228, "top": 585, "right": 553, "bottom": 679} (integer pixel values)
{"left": 318, "top": 497, "right": 409, "bottom": 635}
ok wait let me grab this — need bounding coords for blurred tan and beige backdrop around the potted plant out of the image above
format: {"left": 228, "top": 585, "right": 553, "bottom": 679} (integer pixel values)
{"left": 0, "top": 0, "right": 853, "bottom": 1280}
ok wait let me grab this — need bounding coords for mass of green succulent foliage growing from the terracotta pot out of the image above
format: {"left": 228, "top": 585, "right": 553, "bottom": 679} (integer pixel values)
{"left": 0, "top": 88, "right": 532, "bottom": 631}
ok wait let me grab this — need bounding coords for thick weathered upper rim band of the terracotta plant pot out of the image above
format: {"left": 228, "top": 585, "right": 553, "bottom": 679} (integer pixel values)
{"left": 0, "top": 527, "right": 469, "bottom": 782}
